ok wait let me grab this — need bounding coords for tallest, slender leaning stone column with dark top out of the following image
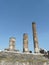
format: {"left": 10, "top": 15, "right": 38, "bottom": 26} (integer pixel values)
{"left": 32, "top": 22, "right": 39, "bottom": 53}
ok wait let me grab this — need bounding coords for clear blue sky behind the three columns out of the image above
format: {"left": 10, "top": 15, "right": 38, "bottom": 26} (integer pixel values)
{"left": 0, "top": 0, "right": 49, "bottom": 51}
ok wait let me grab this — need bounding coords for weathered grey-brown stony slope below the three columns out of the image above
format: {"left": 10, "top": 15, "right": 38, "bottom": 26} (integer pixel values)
{"left": 0, "top": 52, "right": 49, "bottom": 65}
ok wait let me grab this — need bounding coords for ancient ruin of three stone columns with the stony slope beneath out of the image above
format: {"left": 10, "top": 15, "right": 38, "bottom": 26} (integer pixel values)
{"left": 0, "top": 22, "right": 49, "bottom": 65}
